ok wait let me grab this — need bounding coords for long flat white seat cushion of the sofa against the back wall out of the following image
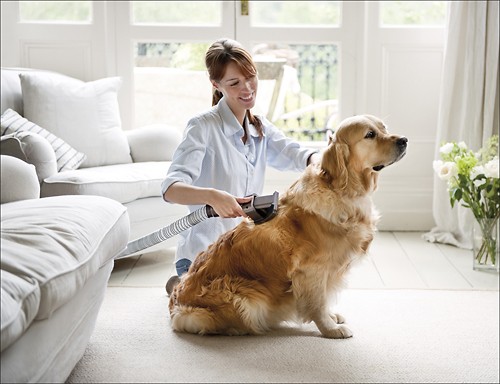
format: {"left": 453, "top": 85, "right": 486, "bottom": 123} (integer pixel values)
{"left": 41, "top": 161, "right": 171, "bottom": 204}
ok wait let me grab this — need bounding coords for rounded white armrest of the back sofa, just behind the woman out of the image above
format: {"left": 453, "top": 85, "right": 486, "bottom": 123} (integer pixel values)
{"left": 125, "top": 124, "right": 182, "bottom": 163}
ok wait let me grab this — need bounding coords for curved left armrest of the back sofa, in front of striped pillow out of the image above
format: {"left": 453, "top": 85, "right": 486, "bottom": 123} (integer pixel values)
{"left": 0, "top": 131, "right": 57, "bottom": 183}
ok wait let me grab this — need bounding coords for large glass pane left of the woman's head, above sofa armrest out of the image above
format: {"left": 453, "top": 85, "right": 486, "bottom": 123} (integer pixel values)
{"left": 134, "top": 42, "right": 212, "bottom": 127}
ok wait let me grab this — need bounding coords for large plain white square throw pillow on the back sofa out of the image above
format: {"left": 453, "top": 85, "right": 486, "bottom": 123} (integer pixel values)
{"left": 19, "top": 73, "right": 132, "bottom": 168}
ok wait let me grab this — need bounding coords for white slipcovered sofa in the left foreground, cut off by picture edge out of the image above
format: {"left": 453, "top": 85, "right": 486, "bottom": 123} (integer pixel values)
{"left": 0, "top": 155, "right": 129, "bottom": 383}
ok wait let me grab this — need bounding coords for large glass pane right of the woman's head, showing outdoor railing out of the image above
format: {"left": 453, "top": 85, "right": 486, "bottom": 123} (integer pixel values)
{"left": 252, "top": 43, "right": 339, "bottom": 141}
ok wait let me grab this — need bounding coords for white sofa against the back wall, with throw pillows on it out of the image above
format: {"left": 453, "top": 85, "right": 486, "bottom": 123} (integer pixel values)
{"left": 1, "top": 68, "right": 188, "bottom": 254}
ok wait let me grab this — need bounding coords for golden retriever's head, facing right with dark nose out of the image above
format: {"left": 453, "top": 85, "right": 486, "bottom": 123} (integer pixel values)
{"left": 321, "top": 115, "right": 408, "bottom": 195}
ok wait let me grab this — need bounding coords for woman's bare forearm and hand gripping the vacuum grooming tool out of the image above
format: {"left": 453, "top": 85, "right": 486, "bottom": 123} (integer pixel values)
{"left": 163, "top": 181, "right": 252, "bottom": 218}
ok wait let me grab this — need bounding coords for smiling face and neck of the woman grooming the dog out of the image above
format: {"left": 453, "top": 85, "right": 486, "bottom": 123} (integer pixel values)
{"left": 213, "top": 62, "right": 258, "bottom": 122}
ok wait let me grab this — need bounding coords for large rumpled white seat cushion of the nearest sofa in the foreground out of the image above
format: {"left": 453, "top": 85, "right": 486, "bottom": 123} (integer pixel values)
{"left": 1, "top": 196, "right": 130, "bottom": 351}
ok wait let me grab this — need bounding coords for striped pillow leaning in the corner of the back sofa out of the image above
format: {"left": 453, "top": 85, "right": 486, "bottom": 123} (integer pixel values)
{"left": 1, "top": 109, "right": 87, "bottom": 172}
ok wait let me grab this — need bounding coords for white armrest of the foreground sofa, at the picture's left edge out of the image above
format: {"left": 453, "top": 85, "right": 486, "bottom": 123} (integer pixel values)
{"left": 0, "top": 155, "right": 40, "bottom": 204}
